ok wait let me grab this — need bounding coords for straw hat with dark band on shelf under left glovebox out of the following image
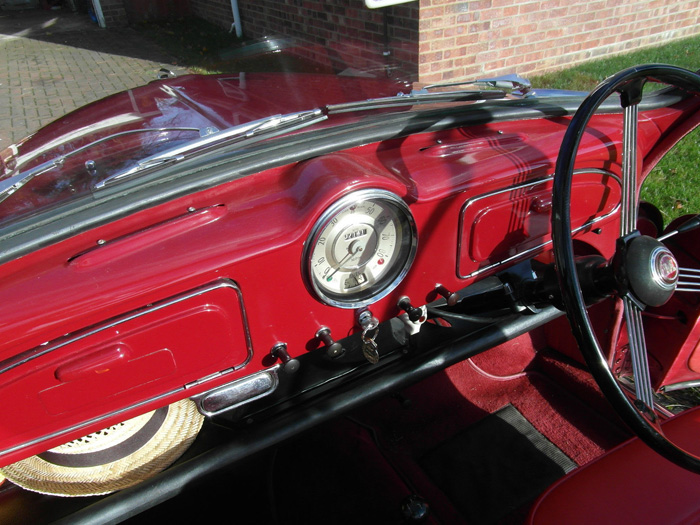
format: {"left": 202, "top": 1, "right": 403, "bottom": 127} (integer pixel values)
{"left": 0, "top": 399, "right": 204, "bottom": 496}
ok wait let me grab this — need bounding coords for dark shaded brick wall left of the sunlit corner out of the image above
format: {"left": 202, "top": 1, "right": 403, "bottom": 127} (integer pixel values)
{"left": 190, "top": 0, "right": 418, "bottom": 78}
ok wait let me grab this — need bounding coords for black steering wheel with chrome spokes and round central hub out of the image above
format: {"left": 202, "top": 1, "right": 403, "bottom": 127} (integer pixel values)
{"left": 552, "top": 64, "right": 700, "bottom": 473}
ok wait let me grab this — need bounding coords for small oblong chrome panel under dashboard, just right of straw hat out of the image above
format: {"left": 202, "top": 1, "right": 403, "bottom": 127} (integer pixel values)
{"left": 192, "top": 365, "right": 280, "bottom": 416}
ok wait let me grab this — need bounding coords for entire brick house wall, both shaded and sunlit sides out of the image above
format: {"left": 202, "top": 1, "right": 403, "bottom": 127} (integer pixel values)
{"left": 189, "top": 0, "right": 700, "bottom": 82}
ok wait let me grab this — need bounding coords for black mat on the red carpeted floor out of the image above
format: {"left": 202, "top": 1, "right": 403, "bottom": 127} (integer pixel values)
{"left": 420, "top": 405, "right": 576, "bottom": 524}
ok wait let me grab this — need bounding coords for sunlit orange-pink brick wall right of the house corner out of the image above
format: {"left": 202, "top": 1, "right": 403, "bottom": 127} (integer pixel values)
{"left": 419, "top": 0, "right": 700, "bottom": 82}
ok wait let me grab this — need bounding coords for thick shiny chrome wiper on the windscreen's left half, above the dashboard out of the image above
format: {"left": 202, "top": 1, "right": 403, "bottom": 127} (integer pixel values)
{"left": 95, "top": 109, "right": 328, "bottom": 190}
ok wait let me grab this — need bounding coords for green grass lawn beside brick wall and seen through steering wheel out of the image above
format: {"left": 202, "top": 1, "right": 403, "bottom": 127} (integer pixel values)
{"left": 530, "top": 37, "right": 700, "bottom": 224}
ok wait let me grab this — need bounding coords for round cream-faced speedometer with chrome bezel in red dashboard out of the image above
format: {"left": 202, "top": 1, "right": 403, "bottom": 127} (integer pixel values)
{"left": 304, "top": 190, "right": 417, "bottom": 308}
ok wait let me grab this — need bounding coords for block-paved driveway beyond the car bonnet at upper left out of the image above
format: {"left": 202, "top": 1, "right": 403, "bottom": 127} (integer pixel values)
{"left": 0, "top": 9, "right": 186, "bottom": 149}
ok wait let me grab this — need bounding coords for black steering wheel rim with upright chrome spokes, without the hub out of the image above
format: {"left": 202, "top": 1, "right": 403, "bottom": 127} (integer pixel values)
{"left": 552, "top": 64, "right": 700, "bottom": 473}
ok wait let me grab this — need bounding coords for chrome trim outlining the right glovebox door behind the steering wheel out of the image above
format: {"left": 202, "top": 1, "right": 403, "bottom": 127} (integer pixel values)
{"left": 457, "top": 169, "right": 622, "bottom": 279}
